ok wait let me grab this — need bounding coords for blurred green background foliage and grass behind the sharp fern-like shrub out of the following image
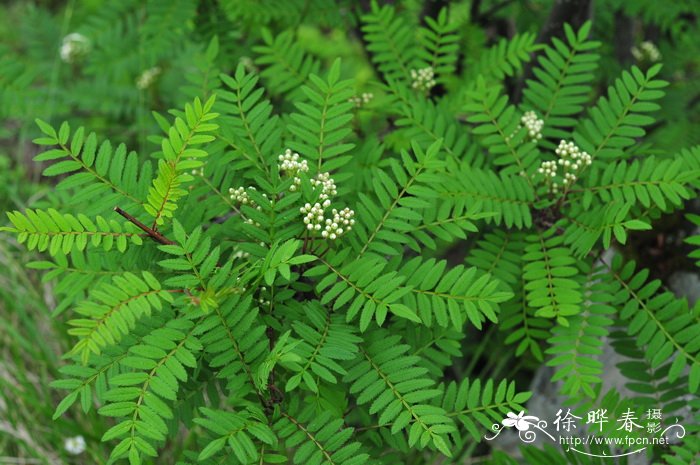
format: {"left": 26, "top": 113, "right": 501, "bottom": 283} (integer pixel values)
{"left": 0, "top": 0, "right": 700, "bottom": 464}
